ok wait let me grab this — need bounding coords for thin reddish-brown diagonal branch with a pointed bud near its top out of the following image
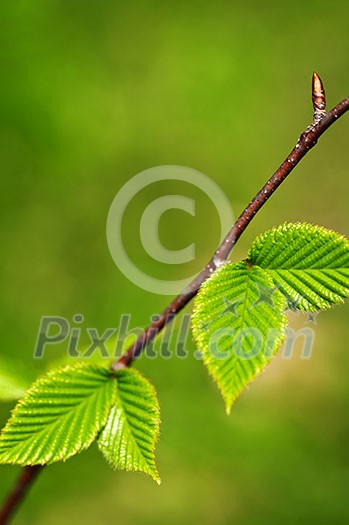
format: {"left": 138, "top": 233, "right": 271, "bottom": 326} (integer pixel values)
{"left": 0, "top": 73, "right": 349, "bottom": 525}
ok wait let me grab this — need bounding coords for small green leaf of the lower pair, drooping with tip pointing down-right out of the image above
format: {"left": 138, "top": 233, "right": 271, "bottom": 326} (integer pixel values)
{"left": 98, "top": 369, "right": 160, "bottom": 483}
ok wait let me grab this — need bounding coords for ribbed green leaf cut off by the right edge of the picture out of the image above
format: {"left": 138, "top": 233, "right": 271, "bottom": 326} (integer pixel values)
{"left": 248, "top": 223, "right": 349, "bottom": 311}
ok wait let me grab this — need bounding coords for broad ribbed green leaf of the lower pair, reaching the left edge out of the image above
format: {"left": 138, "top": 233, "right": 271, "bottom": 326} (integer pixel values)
{"left": 0, "top": 364, "right": 116, "bottom": 465}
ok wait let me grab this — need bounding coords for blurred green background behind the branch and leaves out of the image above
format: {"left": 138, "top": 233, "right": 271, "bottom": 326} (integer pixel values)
{"left": 0, "top": 0, "right": 349, "bottom": 525}
